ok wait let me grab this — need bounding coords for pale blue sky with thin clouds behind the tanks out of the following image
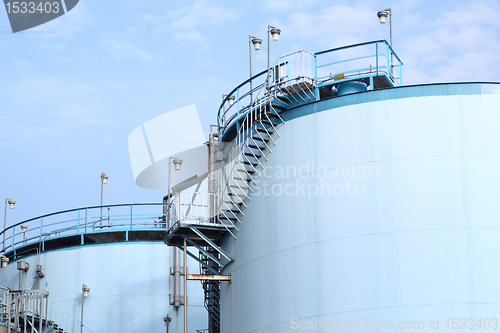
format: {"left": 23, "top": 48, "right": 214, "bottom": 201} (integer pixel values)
{"left": 0, "top": 0, "right": 500, "bottom": 224}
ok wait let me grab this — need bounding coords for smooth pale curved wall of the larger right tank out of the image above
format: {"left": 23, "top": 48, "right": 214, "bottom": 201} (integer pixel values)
{"left": 221, "top": 84, "right": 500, "bottom": 333}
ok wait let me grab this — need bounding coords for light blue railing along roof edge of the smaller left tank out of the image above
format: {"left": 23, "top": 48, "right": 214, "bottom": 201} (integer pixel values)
{"left": 0, "top": 203, "right": 166, "bottom": 253}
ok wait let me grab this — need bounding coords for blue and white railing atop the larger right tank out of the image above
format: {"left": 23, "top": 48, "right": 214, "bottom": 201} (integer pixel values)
{"left": 217, "top": 40, "right": 403, "bottom": 135}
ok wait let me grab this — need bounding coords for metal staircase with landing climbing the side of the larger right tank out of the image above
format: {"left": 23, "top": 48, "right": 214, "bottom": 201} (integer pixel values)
{"left": 166, "top": 95, "right": 286, "bottom": 333}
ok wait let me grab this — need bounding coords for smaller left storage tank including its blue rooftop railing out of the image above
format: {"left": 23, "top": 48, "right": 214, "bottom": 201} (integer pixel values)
{"left": 0, "top": 203, "right": 207, "bottom": 333}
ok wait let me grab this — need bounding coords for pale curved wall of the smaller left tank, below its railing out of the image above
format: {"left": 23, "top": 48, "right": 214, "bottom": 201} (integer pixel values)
{"left": 0, "top": 242, "right": 207, "bottom": 333}
